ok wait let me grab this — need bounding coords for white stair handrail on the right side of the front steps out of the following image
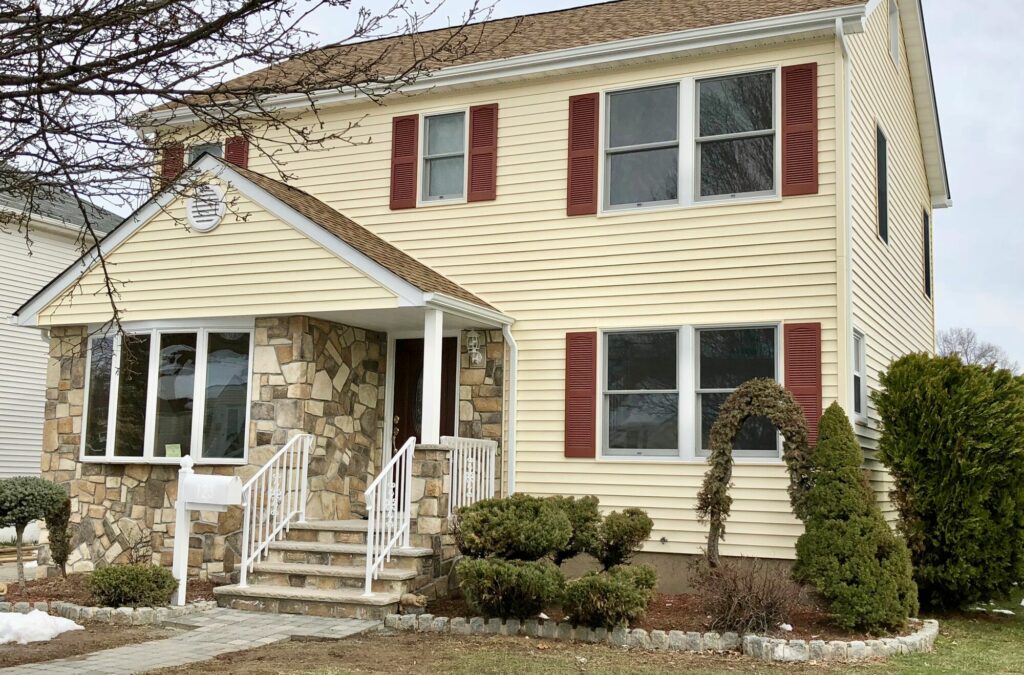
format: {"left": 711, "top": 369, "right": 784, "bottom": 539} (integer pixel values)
{"left": 364, "top": 437, "right": 416, "bottom": 595}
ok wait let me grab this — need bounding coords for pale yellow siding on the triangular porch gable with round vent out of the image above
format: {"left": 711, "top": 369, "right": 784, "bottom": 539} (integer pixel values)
{"left": 39, "top": 186, "right": 397, "bottom": 326}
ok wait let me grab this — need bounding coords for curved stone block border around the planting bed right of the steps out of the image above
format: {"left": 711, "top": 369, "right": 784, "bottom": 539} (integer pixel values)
{"left": 384, "top": 614, "right": 939, "bottom": 663}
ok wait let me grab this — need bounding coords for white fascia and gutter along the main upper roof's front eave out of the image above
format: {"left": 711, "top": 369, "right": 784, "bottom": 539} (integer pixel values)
{"left": 148, "top": 4, "right": 866, "bottom": 128}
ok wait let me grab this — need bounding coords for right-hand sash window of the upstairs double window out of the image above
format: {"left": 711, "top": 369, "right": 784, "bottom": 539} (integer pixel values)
{"left": 696, "top": 72, "right": 775, "bottom": 198}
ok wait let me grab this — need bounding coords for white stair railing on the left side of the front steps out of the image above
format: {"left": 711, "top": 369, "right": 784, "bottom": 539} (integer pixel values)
{"left": 239, "top": 434, "right": 313, "bottom": 586}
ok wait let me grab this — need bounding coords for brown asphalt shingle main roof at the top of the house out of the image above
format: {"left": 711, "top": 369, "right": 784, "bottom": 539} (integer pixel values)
{"left": 216, "top": 0, "right": 865, "bottom": 91}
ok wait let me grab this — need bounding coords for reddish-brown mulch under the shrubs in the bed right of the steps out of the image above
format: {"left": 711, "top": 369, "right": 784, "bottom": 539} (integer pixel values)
{"left": 427, "top": 593, "right": 884, "bottom": 640}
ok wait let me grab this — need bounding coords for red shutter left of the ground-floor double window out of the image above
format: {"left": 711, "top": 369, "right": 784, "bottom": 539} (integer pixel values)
{"left": 565, "top": 333, "right": 597, "bottom": 457}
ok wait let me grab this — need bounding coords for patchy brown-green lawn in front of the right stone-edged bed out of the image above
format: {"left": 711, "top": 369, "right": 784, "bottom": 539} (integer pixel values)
{"left": 160, "top": 595, "right": 1024, "bottom": 675}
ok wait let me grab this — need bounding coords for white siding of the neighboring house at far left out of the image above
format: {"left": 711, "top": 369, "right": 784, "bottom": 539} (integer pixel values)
{"left": 0, "top": 228, "right": 79, "bottom": 477}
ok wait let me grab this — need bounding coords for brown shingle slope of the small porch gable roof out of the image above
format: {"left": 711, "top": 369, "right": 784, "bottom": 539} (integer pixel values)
{"left": 225, "top": 160, "right": 495, "bottom": 309}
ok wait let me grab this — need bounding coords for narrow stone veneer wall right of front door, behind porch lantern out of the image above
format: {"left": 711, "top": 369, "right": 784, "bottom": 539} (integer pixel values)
{"left": 459, "top": 329, "right": 505, "bottom": 492}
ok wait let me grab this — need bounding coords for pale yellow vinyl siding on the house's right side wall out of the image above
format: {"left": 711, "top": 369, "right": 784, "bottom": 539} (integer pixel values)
{"left": 851, "top": 0, "right": 935, "bottom": 518}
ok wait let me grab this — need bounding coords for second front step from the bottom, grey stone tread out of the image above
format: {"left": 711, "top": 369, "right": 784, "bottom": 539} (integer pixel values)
{"left": 250, "top": 562, "right": 415, "bottom": 595}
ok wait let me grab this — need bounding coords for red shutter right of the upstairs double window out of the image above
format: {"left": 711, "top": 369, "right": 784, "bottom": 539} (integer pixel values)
{"left": 782, "top": 64, "right": 818, "bottom": 197}
